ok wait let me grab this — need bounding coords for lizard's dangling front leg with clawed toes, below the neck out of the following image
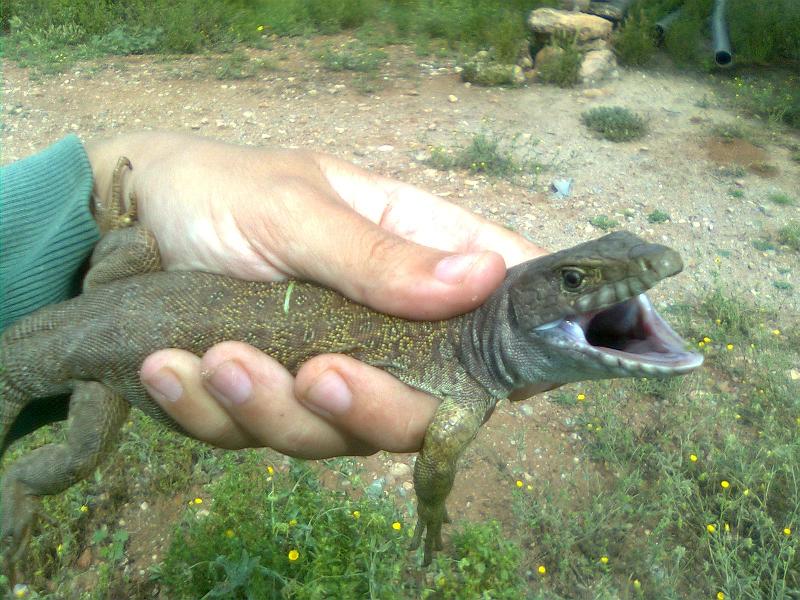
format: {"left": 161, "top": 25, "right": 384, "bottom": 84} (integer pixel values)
{"left": 411, "top": 398, "right": 494, "bottom": 565}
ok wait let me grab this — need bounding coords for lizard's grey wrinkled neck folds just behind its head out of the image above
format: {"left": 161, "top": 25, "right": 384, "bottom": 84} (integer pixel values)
{"left": 456, "top": 278, "right": 530, "bottom": 398}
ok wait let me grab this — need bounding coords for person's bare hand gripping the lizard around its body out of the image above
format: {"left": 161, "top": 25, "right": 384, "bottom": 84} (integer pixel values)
{"left": 87, "top": 133, "right": 544, "bottom": 458}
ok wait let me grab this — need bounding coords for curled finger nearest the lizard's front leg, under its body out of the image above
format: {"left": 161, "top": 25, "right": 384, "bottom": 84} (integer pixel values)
{"left": 295, "top": 354, "right": 439, "bottom": 452}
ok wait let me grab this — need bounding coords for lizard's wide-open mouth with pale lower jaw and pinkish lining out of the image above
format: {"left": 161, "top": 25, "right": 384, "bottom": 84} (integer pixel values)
{"left": 537, "top": 294, "right": 703, "bottom": 376}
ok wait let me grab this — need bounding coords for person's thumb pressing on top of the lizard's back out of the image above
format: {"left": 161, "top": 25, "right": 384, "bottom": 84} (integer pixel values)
{"left": 268, "top": 196, "right": 506, "bottom": 320}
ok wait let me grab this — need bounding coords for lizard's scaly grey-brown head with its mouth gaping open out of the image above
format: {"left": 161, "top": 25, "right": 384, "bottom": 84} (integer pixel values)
{"left": 508, "top": 231, "right": 703, "bottom": 380}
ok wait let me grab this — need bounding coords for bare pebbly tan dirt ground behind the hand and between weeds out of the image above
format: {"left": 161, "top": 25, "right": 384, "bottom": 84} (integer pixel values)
{"left": 2, "top": 38, "right": 800, "bottom": 580}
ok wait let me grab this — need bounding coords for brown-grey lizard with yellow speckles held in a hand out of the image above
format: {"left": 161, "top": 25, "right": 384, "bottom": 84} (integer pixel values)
{"left": 0, "top": 157, "right": 703, "bottom": 565}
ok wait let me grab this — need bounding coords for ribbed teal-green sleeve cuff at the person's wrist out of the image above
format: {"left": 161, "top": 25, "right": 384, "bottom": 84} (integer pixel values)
{"left": 0, "top": 135, "right": 99, "bottom": 331}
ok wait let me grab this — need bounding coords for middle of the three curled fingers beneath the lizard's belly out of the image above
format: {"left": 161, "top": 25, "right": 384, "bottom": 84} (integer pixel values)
{"left": 202, "top": 342, "right": 377, "bottom": 458}
